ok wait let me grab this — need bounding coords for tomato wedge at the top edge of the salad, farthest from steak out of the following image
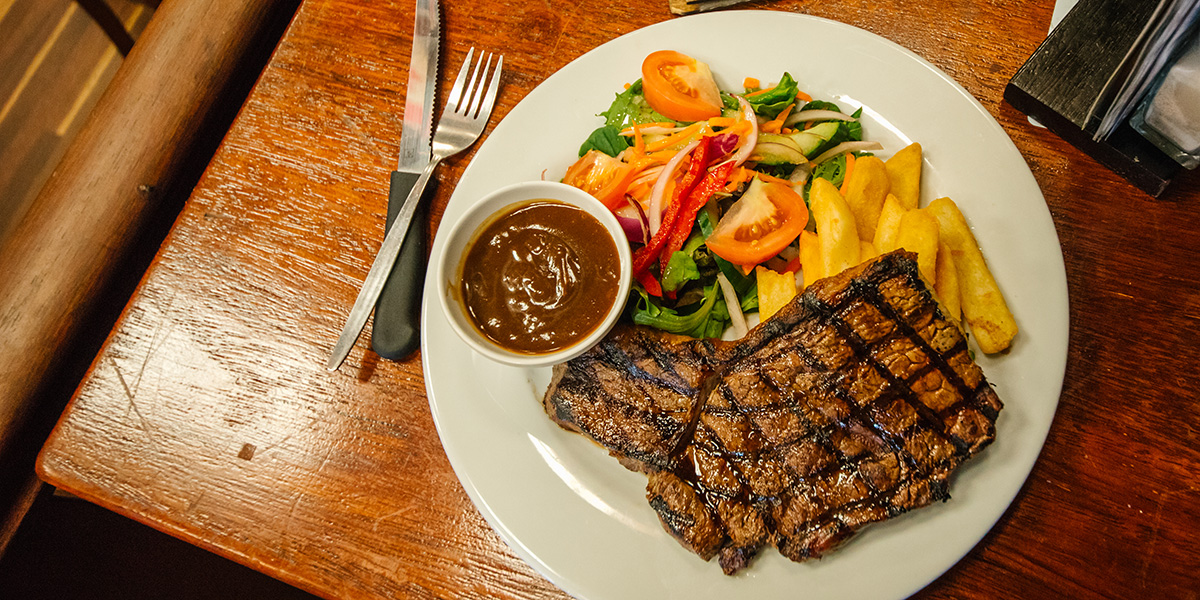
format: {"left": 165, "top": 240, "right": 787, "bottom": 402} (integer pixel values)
{"left": 642, "top": 50, "right": 721, "bottom": 121}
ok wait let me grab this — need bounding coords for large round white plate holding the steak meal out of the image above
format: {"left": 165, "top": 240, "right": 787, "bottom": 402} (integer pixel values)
{"left": 421, "top": 11, "right": 1068, "bottom": 600}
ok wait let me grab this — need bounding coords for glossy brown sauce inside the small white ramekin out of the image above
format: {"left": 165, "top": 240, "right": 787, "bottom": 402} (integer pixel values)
{"left": 461, "top": 200, "right": 620, "bottom": 354}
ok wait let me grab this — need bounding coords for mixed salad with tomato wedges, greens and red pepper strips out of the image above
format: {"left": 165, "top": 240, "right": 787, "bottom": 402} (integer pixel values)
{"left": 563, "top": 50, "right": 882, "bottom": 337}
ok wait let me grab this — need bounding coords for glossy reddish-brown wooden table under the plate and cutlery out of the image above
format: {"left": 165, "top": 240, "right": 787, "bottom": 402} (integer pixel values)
{"left": 40, "top": 0, "right": 1200, "bottom": 599}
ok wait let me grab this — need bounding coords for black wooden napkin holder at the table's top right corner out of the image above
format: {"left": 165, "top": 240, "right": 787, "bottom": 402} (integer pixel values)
{"left": 1004, "top": 0, "right": 1182, "bottom": 198}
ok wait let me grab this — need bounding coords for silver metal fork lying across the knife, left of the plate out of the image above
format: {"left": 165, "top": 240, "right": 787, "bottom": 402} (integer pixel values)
{"left": 325, "top": 48, "right": 504, "bottom": 371}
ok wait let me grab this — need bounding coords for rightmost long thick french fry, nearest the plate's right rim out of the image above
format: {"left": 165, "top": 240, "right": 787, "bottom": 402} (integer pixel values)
{"left": 928, "top": 198, "right": 1016, "bottom": 354}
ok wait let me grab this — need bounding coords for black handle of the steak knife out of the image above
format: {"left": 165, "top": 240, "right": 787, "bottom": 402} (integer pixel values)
{"left": 371, "top": 170, "right": 430, "bottom": 360}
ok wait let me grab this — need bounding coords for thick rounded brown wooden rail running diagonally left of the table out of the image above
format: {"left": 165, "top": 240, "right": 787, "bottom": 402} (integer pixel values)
{"left": 0, "top": 0, "right": 299, "bottom": 553}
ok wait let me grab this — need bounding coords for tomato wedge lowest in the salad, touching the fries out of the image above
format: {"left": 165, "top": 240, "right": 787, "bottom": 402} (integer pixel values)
{"left": 704, "top": 178, "right": 809, "bottom": 265}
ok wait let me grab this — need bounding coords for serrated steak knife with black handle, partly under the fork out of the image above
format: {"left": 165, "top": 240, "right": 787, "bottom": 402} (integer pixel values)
{"left": 371, "top": 0, "right": 440, "bottom": 360}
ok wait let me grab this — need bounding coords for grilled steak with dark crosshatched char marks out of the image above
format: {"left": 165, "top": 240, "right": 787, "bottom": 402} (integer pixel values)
{"left": 544, "top": 252, "right": 1002, "bottom": 574}
